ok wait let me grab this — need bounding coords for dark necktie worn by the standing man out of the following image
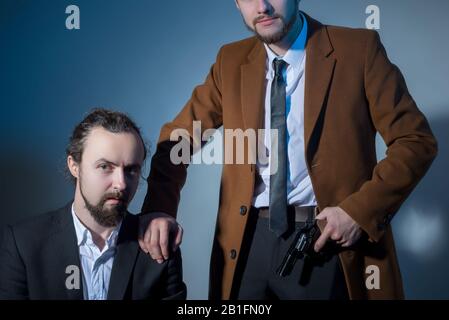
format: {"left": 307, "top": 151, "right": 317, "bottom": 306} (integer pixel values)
{"left": 269, "top": 59, "right": 288, "bottom": 237}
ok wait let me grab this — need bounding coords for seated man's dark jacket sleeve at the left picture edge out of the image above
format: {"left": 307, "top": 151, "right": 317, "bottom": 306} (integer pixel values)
{"left": 0, "top": 226, "right": 28, "bottom": 300}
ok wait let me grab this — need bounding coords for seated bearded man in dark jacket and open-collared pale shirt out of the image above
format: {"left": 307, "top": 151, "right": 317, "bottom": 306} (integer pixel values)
{"left": 0, "top": 109, "right": 186, "bottom": 300}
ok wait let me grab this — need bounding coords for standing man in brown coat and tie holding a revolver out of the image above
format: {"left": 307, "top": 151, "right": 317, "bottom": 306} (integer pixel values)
{"left": 140, "top": 0, "right": 437, "bottom": 299}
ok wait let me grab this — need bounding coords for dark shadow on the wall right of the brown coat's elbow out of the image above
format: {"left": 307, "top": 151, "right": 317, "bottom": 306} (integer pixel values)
{"left": 393, "top": 113, "right": 449, "bottom": 299}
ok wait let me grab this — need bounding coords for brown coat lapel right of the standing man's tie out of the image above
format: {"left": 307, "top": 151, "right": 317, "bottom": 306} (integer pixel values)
{"left": 304, "top": 14, "right": 336, "bottom": 160}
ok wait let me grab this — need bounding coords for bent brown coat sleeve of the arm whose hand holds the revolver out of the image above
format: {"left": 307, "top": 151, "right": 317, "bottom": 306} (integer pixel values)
{"left": 339, "top": 31, "right": 437, "bottom": 241}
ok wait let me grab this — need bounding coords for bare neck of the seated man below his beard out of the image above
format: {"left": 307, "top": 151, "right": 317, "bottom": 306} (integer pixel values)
{"left": 73, "top": 189, "right": 115, "bottom": 250}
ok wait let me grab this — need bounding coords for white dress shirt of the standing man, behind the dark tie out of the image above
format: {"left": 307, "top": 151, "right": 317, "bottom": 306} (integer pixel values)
{"left": 253, "top": 14, "right": 316, "bottom": 208}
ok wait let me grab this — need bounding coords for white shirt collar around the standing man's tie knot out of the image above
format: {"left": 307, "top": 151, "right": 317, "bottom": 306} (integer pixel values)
{"left": 264, "top": 12, "right": 308, "bottom": 79}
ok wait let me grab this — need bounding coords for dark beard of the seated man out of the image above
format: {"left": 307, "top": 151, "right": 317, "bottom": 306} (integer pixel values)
{"left": 80, "top": 179, "right": 127, "bottom": 228}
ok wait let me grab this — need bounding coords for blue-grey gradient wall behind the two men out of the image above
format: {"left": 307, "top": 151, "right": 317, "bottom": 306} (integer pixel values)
{"left": 0, "top": 0, "right": 449, "bottom": 299}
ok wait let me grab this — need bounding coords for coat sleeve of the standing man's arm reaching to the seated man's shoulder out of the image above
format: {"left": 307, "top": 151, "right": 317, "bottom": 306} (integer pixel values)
{"left": 141, "top": 50, "right": 223, "bottom": 217}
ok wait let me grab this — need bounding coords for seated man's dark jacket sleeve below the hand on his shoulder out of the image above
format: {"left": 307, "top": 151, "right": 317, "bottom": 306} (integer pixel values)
{"left": 162, "top": 249, "right": 187, "bottom": 300}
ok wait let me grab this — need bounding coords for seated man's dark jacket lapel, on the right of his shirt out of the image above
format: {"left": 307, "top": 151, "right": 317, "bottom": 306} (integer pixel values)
{"left": 108, "top": 213, "right": 139, "bottom": 300}
